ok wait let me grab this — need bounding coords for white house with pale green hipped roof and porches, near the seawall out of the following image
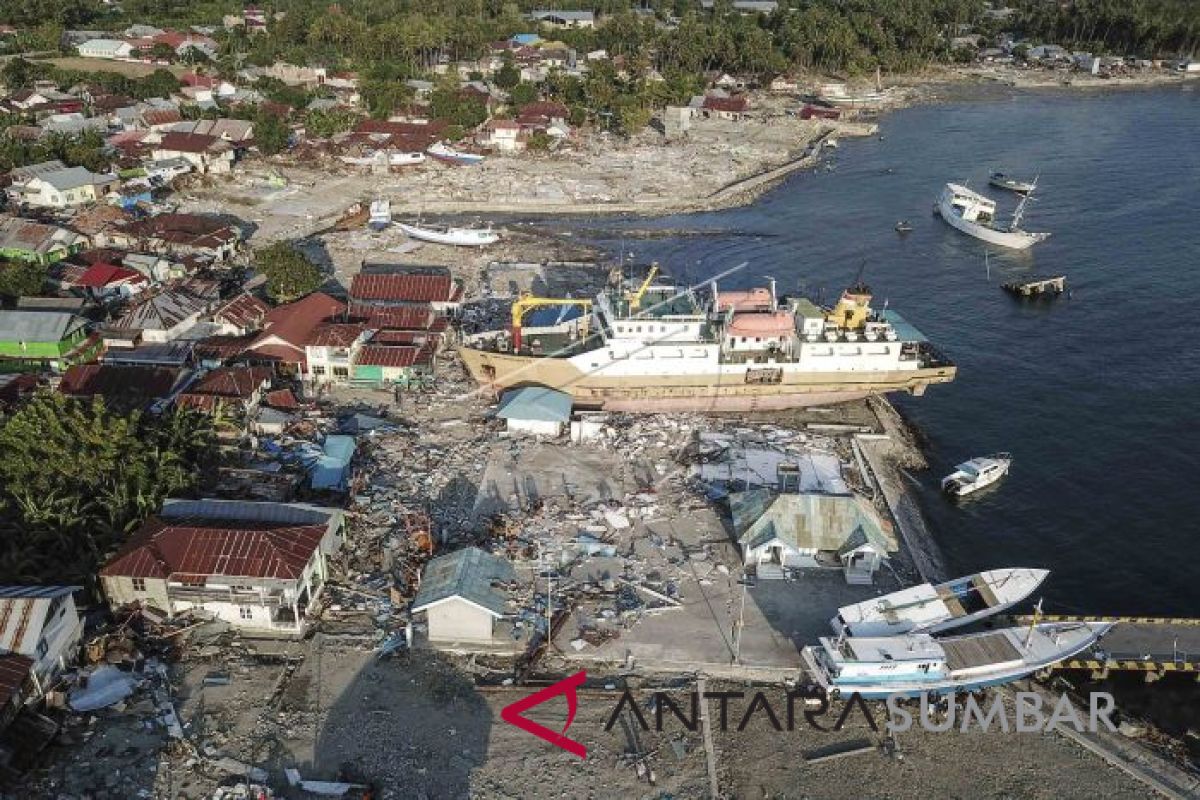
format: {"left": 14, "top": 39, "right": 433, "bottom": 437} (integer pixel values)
{"left": 730, "top": 489, "right": 899, "bottom": 584}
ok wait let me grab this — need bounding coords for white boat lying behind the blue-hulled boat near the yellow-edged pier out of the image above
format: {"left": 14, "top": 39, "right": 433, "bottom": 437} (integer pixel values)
{"left": 830, "top": 567, "right": 1050, "bottom": 636}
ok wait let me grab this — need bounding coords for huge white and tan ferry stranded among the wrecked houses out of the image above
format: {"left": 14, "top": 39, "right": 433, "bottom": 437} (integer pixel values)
{"left": 460, "top": 269, "right": 955, "bottom": 411}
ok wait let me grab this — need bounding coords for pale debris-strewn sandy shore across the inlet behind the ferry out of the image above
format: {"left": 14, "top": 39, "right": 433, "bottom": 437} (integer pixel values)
{"left": 171, "top": 97, "right": 874, "bottom": 245}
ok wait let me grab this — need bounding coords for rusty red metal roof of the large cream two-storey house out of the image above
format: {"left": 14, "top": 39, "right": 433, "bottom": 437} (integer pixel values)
{"left": 100, "top": 518, "right": 325, "bottom": 579}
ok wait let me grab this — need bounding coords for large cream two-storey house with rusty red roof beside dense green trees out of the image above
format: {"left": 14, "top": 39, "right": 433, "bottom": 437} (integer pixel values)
{"left": 100, "top": 500, "right": 343, "bottom": 636}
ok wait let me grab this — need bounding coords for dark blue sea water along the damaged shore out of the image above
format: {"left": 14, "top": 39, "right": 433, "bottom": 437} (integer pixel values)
{"left": 568, "top": 85, "right": 1200, "bottom": 616}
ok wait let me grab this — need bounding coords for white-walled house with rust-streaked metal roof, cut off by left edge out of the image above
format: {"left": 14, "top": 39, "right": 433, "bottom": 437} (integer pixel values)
{"left": 0, "top": 587, "right": 83, "bottom": 694}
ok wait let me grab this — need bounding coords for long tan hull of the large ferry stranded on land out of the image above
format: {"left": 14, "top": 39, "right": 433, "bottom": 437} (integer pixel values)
{"left": 460, "top": 348, "right": 955, "bottom": 411}
